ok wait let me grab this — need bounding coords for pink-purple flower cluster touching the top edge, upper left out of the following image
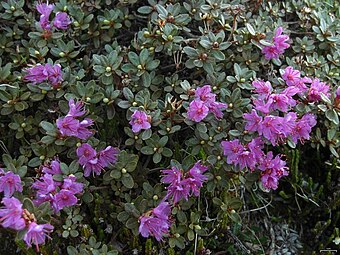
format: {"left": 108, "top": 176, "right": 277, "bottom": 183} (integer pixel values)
{"left": 36, "top": 2, "right": 71, "bottom": 31}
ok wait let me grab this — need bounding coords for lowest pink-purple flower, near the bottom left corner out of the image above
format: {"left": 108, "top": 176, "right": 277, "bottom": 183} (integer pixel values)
{"left": 24, "top": 221, "right": 54, "bottom": 251}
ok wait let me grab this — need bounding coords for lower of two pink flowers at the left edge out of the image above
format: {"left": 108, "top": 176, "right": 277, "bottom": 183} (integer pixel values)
{"left": 0, "top": 197, "right": 25, "bottom": 230}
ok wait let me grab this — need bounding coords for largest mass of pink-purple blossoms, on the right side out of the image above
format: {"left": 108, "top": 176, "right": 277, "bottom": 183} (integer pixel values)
{"left": 222, "top": 66, "right": 329, "bottom": 189}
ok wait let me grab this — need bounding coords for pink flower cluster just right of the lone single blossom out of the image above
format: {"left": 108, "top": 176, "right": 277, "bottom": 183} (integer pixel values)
{"left": 188, "top": 85, "right": 227, "bottom": 122}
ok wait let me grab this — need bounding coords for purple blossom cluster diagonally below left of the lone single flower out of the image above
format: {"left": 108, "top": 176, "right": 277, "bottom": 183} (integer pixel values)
{"left": 77, "top": 143, "right": 119, "bottom": 177}
